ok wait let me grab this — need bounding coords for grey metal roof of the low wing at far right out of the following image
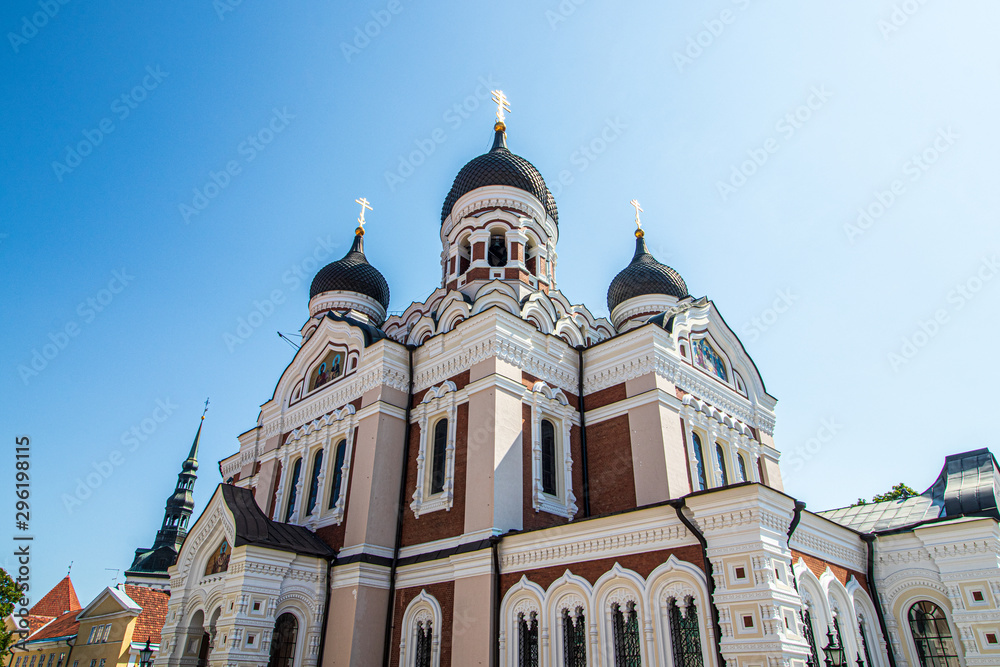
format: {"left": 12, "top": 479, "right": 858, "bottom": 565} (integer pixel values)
{"left": 819, "top": 448, "right": 1000, "bottom": 533}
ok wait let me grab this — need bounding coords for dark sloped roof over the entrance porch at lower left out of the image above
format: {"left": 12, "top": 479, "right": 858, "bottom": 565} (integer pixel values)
{"left": 222, "top": 484, "right": 333, "bottom": 558}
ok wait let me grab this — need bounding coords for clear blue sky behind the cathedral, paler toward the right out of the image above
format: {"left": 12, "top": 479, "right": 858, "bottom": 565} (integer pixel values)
{"left": 0, "top": 0, "right": 1000, "bottom": 600}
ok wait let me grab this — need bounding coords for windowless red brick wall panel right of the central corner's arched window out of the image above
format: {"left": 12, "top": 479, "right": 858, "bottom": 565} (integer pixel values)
{"left": 587, "top": 414, "right": 636, "bottom": 516}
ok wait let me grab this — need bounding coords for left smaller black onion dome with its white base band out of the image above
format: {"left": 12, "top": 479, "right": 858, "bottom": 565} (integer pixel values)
{"left": 309, "top": 227, "right": 389, "bottom": 325}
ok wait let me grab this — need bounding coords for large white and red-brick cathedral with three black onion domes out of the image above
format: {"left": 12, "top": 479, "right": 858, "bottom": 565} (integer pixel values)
{"left": 148, "top": 92, "right": 1000, "bottom": 667}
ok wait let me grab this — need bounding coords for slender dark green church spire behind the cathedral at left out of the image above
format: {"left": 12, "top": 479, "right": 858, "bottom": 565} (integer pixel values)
{"left": 125, "top": 399, "right": 208, "bottom": 589}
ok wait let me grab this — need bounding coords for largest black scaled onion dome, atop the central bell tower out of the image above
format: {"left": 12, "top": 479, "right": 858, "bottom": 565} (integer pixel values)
{"left": 441, "top": 127, "right": 559, "bottom": 225}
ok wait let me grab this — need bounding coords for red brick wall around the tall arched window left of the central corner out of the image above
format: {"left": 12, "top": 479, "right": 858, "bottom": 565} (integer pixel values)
{"left": 403, "top": 402, "right": 469, "bottom": 547}
